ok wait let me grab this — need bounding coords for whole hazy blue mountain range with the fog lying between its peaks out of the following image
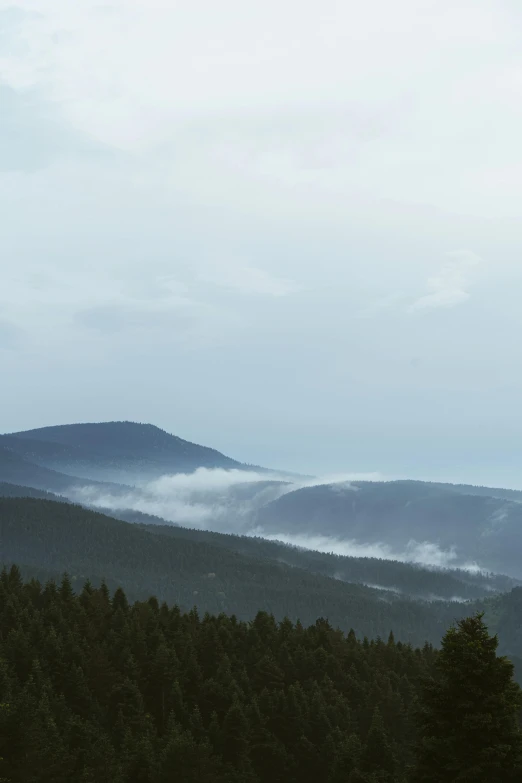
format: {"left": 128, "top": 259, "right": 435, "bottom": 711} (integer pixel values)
{"left": 0, "top": 422, "right": 522, "bottom": 580}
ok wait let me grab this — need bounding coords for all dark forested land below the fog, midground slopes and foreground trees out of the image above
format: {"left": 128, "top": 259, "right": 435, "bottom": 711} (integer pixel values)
{"left": 0, "top": 494, "right": 522, "bottom": 783}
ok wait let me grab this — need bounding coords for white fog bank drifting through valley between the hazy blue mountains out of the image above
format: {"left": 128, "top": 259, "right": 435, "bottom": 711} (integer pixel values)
{"left": 71, "top": 468, "right": 480, "bottom": 571}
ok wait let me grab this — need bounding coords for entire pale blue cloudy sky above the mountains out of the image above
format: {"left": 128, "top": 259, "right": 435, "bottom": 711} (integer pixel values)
{"left": 0, "top": 0, "right": 522, "bottom": 487}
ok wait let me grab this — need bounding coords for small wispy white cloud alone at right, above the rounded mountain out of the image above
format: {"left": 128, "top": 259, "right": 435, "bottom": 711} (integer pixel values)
{"left": 410, "top": 250, "right": 483, "bottom": 311}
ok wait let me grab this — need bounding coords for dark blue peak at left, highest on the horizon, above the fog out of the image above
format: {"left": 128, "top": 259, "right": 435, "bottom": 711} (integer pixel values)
{"left": 0, "top": 421, "right": 247, "bottom": 484}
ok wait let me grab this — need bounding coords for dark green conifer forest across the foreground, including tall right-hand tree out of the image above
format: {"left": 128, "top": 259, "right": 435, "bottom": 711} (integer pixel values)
{"left": 4, "top": 566, "right": 522, "bottom": 783}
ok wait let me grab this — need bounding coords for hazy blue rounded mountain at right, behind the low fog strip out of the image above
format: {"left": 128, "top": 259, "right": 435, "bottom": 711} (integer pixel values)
{"left": 255, "top": 481, "right": 522, "bottom": 578}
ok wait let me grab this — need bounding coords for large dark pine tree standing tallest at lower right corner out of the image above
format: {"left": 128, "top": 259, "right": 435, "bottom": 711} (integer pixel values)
{"left": 412, "top": 614, "right": 522, "bottom": 783}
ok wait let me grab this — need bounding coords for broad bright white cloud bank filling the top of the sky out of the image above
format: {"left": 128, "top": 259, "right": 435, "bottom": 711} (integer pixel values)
{"left": 0, "top": 0, "right": 521, "bottom": 213}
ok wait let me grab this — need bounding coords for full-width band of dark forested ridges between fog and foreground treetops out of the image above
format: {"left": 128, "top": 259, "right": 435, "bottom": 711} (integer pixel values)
{"left": 5, "top": 497, "right": 522, "bottom": 656}
